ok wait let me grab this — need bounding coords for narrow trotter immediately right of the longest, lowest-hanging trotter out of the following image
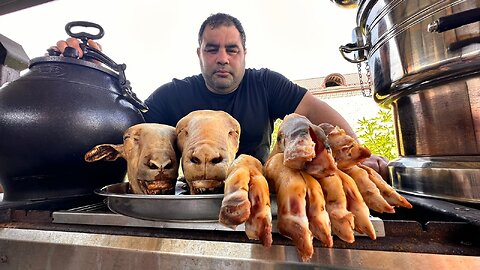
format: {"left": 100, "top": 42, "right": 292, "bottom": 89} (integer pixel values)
{"left": 300, "top": 172, "right": 333, "bottom": 247}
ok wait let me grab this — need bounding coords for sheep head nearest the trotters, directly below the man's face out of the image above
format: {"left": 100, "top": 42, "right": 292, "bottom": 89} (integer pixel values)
{"left": 177, "top": 110, "right": 240, "bottom": 194}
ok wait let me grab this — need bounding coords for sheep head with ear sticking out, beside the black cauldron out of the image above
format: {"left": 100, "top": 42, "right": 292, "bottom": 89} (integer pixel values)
{"left": 85, "top": 123, "right": 179, "bottom": 194}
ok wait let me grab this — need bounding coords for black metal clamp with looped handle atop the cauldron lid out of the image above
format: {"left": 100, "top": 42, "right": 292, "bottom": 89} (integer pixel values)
{"left": 65, "top": 21, "right": 148, "bottom": 112}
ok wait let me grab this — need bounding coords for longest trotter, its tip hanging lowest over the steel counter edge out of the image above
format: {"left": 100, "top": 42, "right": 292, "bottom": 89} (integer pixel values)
{"left": 265, "top": 153, "right": 313, "bottom": 261}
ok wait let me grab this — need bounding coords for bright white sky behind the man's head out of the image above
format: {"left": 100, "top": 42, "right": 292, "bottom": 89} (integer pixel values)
{"left": 0, "top": 0, "right": 357, "bottom": 100}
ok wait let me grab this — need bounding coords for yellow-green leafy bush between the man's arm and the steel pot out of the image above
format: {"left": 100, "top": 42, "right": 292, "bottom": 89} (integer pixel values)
{"left": 356, "top": 109, "right": 398, "bottom": 160}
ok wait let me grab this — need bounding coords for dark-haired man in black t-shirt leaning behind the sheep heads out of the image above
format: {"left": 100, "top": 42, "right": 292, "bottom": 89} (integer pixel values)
{"left": 53, "top": 13, "right": 386, "bottom": 176}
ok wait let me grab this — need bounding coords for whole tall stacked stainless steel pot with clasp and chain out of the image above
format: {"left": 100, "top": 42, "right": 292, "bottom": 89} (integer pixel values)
{"left": 340, "top": 0, "right": 480, "bottom": 202}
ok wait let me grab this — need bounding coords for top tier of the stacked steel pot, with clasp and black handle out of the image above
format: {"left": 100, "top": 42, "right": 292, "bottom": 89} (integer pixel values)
{"left": 340, "top": 0, "right": 480, "bottom": 102}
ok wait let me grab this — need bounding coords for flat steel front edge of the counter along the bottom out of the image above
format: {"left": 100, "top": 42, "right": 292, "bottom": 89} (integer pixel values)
{"left": 0, "top": 228, "right": 480, "bottom": 269}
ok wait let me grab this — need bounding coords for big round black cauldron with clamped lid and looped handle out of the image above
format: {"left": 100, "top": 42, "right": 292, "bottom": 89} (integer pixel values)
{"left": 0, "top": 22, "right": 146, "bottom": 202}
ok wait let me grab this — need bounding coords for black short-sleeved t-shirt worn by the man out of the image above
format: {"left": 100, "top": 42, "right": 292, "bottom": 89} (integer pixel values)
{"left": 144, "top": 69, "right": 307, "bottom": 163}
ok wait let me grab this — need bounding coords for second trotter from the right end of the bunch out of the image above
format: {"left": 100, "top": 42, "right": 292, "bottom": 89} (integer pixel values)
{"left": 344, "top": 165, "right": 395, "bottom": 213}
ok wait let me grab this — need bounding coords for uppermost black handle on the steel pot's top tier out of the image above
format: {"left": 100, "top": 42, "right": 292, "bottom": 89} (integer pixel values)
{"left": 427, "top": 8, "right": 480, "bottom": 33}
